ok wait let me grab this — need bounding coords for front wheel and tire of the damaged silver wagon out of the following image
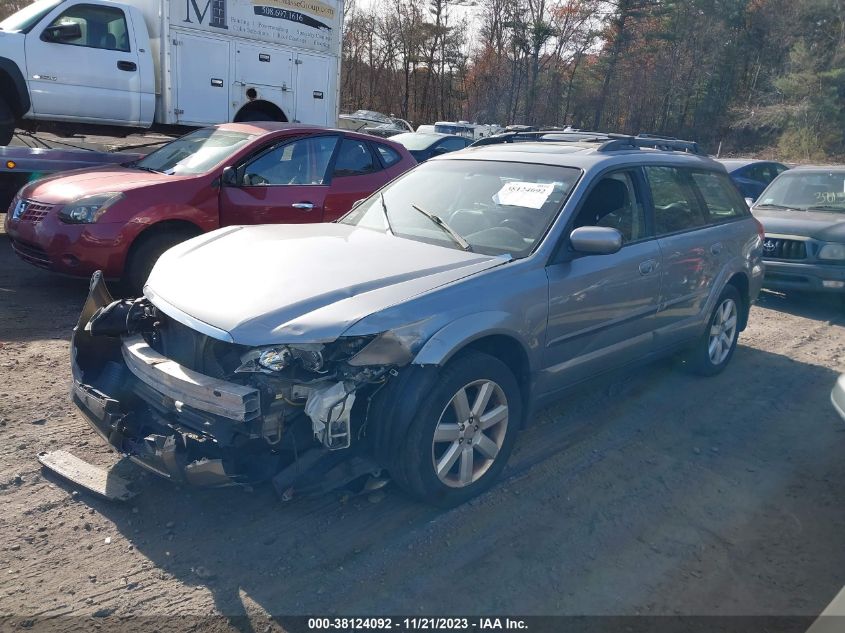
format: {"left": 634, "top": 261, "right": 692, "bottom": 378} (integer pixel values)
{"left": 394, "top": 351, "right": 522, "bottom": 507}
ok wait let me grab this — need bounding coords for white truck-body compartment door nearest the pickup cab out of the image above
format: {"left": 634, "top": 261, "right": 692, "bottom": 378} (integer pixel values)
{"left": 174, "top": 33, "right": 229, "bottom": 125}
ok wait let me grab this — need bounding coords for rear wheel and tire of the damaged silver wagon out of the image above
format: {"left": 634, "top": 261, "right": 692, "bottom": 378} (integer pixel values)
{"left": 686, "top": 284, "right": 744, "bottom": 376}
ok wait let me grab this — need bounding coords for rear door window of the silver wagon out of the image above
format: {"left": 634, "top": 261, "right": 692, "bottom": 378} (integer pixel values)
{"left": 645, "top": 166, "right": 709, "bottom": 235}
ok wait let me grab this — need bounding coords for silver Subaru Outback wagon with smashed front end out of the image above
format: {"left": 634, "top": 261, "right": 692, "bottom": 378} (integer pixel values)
{"left": 67, "top": 134, "right": 763, "bottom": 505}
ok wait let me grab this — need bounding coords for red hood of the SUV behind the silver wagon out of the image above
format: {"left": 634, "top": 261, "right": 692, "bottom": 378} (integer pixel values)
{"left": 22, "top": 167, "right": 186, "bottom": 204}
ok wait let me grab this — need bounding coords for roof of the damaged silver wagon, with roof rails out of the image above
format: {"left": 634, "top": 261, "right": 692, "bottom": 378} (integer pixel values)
{"left": 432, "top": 141, "right": 725, "bottom": 171}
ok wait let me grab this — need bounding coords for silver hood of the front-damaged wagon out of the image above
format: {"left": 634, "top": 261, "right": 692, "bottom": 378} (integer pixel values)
{"left": 144, "top": 224, "right": 508, "bottom": 345}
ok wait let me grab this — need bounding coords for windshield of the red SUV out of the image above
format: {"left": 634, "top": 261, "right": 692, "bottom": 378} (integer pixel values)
{"left": 135, "top": 128, "right": 255, "bottom": 175}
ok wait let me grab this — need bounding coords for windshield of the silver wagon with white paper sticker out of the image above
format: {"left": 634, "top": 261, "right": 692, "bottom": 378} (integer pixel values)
{"left": 340, "top": 160, "right": 581, "bottom": 258}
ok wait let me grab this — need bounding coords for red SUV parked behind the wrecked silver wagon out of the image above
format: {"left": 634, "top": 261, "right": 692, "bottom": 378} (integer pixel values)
{"left": 6, "top": 123, "right": 416, "bottom": 289}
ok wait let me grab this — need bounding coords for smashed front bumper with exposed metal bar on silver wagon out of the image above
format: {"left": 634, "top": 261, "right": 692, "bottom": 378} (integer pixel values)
{"left": 71, "top": 274, "right": 281, "bottom": 486}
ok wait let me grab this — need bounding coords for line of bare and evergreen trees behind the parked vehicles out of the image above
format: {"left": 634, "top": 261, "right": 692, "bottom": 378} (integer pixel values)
{"left": 341, "top": 0, "right": 845, "bottom": 159}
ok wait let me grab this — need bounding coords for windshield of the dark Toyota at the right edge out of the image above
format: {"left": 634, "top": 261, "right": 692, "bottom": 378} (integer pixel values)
{"left": 756, "top": 171, "right": 845, "bottom": 213}
